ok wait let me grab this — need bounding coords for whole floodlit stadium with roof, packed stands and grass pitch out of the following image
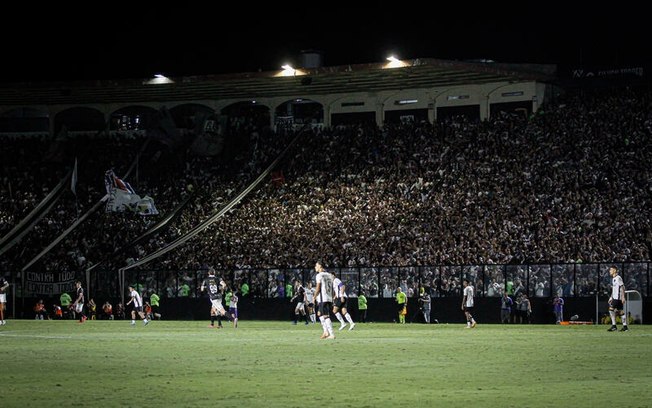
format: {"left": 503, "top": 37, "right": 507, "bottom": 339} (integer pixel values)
{"left": 0, "top": 52, "right": 652, "bottom": 406}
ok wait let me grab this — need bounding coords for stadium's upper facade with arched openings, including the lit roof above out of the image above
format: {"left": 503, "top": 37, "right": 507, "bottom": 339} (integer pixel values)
{"left": 0, "top": 59, "right": 555, "bottom": 135}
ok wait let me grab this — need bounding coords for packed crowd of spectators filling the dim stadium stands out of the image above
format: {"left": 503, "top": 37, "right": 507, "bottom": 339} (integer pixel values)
{"left": 0, "top": 89, "right": 652, "bottom": 300}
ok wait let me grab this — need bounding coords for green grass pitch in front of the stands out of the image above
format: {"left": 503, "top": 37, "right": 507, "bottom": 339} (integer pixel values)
{"left": 0, "top": 320, "right": 652, "bottom": 408}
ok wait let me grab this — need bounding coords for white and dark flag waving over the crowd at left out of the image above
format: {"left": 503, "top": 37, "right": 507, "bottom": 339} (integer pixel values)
{"left": 104, "top": 170, "right": 158, "bottom": 215}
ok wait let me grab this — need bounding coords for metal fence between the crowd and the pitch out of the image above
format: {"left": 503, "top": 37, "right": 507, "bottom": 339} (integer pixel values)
{"left": 62, "top": 262, "right": 652, "bottom": 298}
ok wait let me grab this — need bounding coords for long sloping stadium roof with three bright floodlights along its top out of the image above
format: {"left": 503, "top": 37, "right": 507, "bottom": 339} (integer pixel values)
{"left": 0, "top": 59, "right": 556, "bottom": 106}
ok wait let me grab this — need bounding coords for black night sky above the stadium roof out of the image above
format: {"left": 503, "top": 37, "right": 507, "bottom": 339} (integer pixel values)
{"left": 0, "top": 1, "right": 652, "bottom": 82}
